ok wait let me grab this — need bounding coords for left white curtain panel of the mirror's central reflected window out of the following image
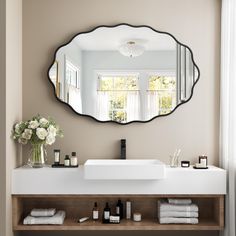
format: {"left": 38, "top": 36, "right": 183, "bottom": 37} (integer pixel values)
{"left": 96, "top": 91, "right": 109, "bottom": 121}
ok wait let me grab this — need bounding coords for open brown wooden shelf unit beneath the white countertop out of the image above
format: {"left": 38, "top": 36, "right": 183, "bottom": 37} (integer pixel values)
{"left": 12, "top": 195, "right": 224, "bottom": 231}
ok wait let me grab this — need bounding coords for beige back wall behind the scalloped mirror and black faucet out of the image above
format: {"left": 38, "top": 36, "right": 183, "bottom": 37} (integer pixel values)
{"left": 23, "top": 0, "right": 220, "bottom": 164}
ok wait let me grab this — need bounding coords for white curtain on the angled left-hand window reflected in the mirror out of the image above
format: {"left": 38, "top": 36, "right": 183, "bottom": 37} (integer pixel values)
{"left": 68, "top": 85, "right": 82, "bottom": 113}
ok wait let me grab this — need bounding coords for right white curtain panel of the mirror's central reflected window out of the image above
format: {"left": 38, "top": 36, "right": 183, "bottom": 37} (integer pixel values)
{"left": 127, "top": 91, "right": 140, "bottom": 122}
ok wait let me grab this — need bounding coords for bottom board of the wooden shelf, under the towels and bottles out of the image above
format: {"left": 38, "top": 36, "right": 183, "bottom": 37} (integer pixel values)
{"left": 14, "top": 219, "right": 223, "bottom": 231}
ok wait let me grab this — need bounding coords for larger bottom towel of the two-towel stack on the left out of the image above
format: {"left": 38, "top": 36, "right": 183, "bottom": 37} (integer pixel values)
{"left": 23, "top": 211, "right": 66, "bottom": 225}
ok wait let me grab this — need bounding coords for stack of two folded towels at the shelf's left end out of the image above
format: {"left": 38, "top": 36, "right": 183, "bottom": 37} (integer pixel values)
{"left": 23, "top": 208, "right": 66, "bottom": 225}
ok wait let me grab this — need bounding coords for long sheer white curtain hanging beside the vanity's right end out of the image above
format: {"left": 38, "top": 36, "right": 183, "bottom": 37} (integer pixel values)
{"left": 220, "top": 0, "right": 236, "bottom": 236}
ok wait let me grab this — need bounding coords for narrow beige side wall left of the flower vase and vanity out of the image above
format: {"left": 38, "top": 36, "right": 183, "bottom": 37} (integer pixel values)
{"left": 0, "top": 0, "right": 22, "bottom": 236}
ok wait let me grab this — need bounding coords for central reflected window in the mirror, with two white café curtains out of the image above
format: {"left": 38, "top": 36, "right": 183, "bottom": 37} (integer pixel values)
{"left": 97, "top": 74, "right": 140, "bottom": 123}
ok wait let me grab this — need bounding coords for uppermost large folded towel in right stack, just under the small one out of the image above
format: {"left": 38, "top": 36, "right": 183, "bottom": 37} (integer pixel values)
{"left": 158, "top": 201, "right": 198, "bottom": 211}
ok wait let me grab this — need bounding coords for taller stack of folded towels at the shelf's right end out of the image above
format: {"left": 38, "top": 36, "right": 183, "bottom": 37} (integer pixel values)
{"left": 158, "top": 198, "right": 198, "bottom": 224}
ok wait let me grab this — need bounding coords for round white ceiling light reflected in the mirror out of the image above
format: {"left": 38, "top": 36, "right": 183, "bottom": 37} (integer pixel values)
{"left": 119, "top": 41, "right": 144, "bottom": 57}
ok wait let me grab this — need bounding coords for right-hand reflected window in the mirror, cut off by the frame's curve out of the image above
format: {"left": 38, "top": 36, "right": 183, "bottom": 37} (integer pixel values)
{"left": 147, "top": 75, "right": 177, "bottom": 118}
